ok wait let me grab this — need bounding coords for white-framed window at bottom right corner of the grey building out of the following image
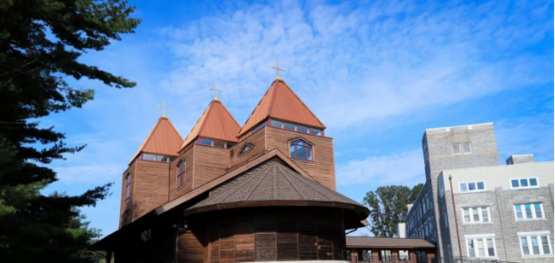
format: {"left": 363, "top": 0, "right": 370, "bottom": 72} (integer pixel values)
{"left": 518, "top": 234, "right": 553, "bottom": 257}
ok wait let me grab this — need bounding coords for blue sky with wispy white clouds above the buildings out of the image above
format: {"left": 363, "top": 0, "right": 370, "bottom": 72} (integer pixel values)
{"left": 42, "top": 0, "right": 555, "bottom": 238}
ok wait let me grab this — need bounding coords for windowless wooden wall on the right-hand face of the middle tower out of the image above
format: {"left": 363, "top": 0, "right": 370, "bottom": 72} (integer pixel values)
{"left": 193, "top": 144, "right": 230, "bottom": 189}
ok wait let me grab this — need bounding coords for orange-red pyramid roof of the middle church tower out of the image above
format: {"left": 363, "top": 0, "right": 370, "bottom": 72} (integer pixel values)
{"left": 180, "top": 99, "right": 241, "bottom": 150}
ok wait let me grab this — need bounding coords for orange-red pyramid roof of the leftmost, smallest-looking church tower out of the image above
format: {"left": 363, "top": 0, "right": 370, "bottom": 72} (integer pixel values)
{"left": 131, "top": 117, "right": 183, "bottom": 160}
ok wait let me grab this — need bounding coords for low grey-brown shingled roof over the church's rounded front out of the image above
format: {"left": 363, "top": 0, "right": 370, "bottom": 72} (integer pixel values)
{"left": 185, "top": 159, "right": 368, "bottom": 221}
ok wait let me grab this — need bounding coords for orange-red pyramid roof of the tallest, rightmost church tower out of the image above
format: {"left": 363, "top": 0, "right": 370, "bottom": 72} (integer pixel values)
{"left": 239, "top": 79, "right": 325, "bottom": 136}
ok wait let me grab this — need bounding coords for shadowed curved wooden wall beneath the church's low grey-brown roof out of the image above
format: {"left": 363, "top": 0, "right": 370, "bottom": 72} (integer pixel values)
{"left": 185, "top": 207, "right": 345, "bottom": 263}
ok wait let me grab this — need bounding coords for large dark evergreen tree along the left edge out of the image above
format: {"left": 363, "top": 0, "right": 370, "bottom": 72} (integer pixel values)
{"left": 0, "top": 0, "right": 140, "bottom": 262}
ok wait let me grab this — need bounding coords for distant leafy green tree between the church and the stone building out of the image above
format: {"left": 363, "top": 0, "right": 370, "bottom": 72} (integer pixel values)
{"left": 364, "top": 184, "right": 423, "bottom": 237}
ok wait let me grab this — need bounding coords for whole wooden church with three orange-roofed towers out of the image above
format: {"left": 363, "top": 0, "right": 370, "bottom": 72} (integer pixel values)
{"left": 92, "top": 77, "right": 369, "bottom": 263}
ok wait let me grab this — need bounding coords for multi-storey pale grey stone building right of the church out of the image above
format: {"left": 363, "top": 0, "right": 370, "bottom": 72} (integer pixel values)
{"left": 406, "top": 123, "right": 555, "bottom": 262}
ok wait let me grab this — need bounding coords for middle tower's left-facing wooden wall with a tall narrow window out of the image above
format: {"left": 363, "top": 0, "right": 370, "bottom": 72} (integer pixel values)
{"left": 169, "top": 145, "right": 195, "bottom": 201}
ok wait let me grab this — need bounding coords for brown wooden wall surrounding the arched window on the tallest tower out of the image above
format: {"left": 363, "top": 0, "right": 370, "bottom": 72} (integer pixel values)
{"left": 263, "top": 127, "right": 335, "bottom": 190}
